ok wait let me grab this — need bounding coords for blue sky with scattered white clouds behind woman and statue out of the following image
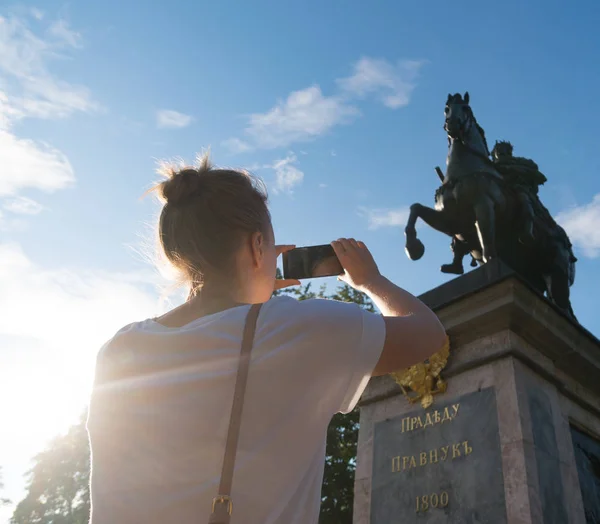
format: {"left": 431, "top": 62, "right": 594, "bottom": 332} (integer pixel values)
{"left": 0, "top": 0, "right": 600, "bottom": 521}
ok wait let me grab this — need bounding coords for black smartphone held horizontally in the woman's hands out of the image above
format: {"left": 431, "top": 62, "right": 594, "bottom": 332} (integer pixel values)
{"left": 283, "top": 244, "right": 344, "bottom": 280}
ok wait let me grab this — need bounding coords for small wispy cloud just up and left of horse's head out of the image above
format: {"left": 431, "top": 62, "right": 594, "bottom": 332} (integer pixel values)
{"left": 338, "top": 57, "right": 423, "bottom": 109}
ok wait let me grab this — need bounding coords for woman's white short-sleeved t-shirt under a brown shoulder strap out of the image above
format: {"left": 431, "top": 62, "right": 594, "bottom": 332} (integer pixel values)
{"left": 88, "top": 297, "right": 385, "bottom": 524}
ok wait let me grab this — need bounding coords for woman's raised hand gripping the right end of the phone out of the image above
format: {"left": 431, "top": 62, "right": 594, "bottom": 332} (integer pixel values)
{"left": 331, "top": 238, "right": 381, "bottom": 291}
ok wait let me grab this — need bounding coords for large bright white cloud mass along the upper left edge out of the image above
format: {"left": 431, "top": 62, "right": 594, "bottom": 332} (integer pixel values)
{"left": 0, "top": 10, "right": 94, "bottom": 201}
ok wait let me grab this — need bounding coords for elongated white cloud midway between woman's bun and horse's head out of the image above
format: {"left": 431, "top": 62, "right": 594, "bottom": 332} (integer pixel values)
{"left": 245, "top": 85, "right": 359, "bottom": 149}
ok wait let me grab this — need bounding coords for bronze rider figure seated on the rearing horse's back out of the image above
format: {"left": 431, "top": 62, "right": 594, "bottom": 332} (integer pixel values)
{"left": 492, "top": 141, "right": 547, "bottom": 245}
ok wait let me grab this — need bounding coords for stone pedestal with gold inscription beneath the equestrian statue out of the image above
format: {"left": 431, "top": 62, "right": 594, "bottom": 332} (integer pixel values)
{"left": 354, "top": 262, "right": 600, "bottom": 524}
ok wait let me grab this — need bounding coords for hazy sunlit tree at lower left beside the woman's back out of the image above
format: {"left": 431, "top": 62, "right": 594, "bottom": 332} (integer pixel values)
{"left": 11, "top": 414, "right": 90, "bottom": 524}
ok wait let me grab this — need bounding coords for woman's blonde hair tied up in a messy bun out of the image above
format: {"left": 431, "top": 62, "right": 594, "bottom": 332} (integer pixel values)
{"left": 149, "top": 154, "right": 271, "bottom": 296}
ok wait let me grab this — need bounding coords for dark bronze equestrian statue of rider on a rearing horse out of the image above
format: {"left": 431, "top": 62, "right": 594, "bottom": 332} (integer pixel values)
{"left": 405, "top": 93, "right": 577, "bottom": 320}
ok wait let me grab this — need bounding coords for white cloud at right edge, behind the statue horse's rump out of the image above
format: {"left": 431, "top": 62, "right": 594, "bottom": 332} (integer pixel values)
{"left": 556, "top": 193, "right": 600, "bottom": 258}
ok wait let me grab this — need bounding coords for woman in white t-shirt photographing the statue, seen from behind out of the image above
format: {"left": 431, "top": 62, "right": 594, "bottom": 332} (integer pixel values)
{"left": 88, "top": 157, "right": 446, "bottom": 524}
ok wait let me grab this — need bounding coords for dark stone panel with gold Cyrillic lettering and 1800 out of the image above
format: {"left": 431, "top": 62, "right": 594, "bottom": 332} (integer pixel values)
{"left": 369, "top": 388, "right": 507, "bottom": 524}
